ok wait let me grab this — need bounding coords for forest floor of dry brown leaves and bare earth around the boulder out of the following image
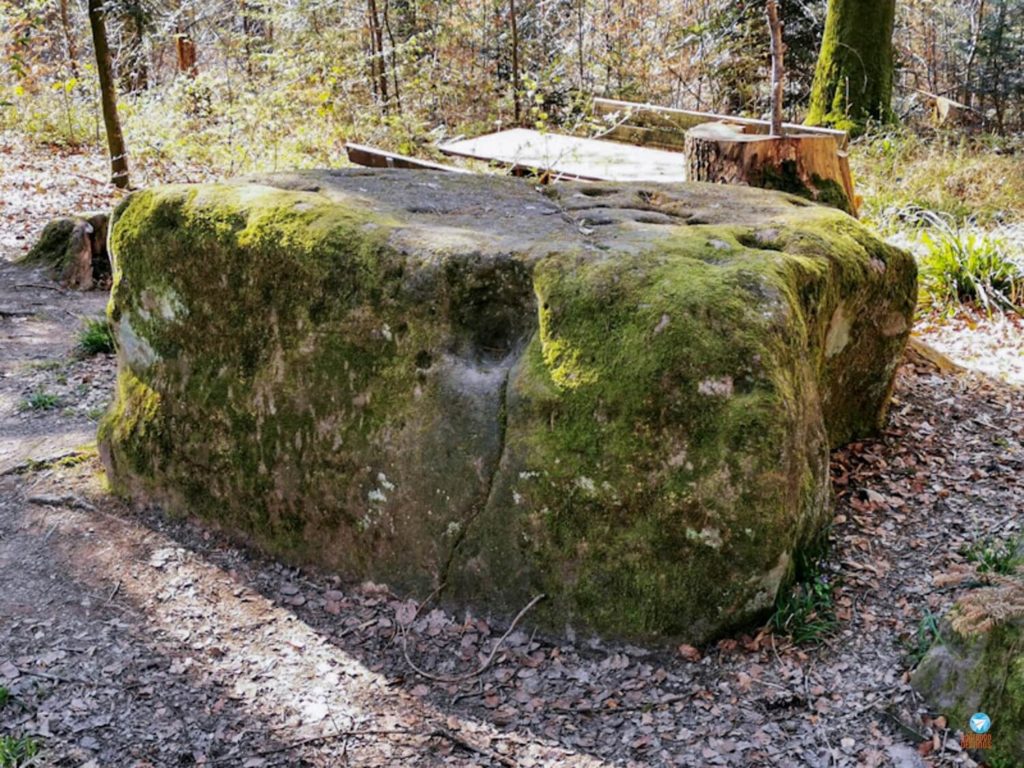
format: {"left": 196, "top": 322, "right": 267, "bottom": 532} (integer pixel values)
{"left": 0, "top": 136, "right": 1024, "bottom": 768}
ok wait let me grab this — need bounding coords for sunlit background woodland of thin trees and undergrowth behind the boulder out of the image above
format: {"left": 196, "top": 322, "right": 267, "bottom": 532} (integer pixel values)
{"left": 0, "top": 0, "right": 1024, "bottom": 315}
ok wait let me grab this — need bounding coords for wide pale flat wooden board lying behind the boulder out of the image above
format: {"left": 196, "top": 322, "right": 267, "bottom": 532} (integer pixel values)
{"left": 438, "top": 128, "right": 686, "bottom": 182}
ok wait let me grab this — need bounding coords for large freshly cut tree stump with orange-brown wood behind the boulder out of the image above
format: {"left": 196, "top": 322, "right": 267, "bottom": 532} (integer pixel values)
{"left": 685, "top": 123, "right": 857, "bottom": 216}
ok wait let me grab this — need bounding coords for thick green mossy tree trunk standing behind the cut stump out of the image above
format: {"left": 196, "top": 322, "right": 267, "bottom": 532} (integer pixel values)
{"left": 807, "top": 0, "right": 896, "bottom": 133}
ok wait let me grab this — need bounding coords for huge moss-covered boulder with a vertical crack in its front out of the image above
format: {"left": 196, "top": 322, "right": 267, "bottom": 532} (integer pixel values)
{"left": 99, "top": 171, "right": 916, "bottom": 642}
